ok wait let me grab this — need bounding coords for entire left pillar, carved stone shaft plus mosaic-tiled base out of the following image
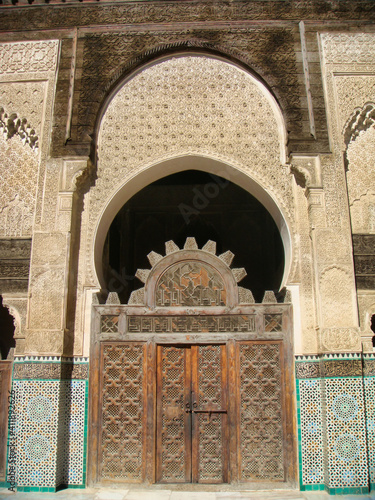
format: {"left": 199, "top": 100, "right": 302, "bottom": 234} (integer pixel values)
{"left": 13, "top": 158, "right": 88, "bottom": 491}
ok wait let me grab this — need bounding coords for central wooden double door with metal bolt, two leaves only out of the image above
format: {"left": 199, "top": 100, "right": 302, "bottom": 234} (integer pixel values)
{"left": 156, "top": 345, "right": 229, "bottom": 483}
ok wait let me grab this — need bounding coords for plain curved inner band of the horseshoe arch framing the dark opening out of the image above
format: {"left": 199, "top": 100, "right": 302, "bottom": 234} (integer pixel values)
{"left": 94, "top": 155, "right": 292, "bottom": 288}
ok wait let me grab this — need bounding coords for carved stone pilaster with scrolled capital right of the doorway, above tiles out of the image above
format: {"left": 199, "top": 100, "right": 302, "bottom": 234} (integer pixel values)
{"left": 292, "top": 155, "right": 361, "bottom": 352}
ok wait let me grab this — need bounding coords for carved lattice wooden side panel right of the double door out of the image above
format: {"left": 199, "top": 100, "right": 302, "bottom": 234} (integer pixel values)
{"left": 239, "top": 342, "right": 284, "bottom": 481}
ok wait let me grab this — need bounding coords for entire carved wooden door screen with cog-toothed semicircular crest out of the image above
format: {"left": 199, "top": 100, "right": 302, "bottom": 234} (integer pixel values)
{"left": 89, "top": 238, "right": 296, "bottom": 487}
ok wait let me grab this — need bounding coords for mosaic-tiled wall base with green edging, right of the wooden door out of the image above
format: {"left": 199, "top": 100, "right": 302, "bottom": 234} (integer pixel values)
{"left": 296, "top": 354, "right": 375, "bottom": 494}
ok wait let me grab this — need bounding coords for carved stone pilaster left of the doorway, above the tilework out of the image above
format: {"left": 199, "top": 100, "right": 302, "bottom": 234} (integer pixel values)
{"left": 25, "top": 159, "right": 87, "bottom": 355}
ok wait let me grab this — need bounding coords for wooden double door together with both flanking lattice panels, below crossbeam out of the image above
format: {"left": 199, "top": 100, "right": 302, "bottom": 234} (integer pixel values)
{"left": 96, "top": 340, "right": 294, "bottom": 484}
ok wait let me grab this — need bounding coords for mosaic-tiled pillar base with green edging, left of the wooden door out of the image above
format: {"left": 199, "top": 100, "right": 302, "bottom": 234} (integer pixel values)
{"left": 9, "top": 356, "right": 88, "bottom": 491}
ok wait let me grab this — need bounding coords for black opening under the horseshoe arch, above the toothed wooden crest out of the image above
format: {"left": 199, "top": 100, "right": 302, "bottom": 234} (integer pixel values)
{"left": 103, "top": 170, "right": 284, "bottom": 303}
